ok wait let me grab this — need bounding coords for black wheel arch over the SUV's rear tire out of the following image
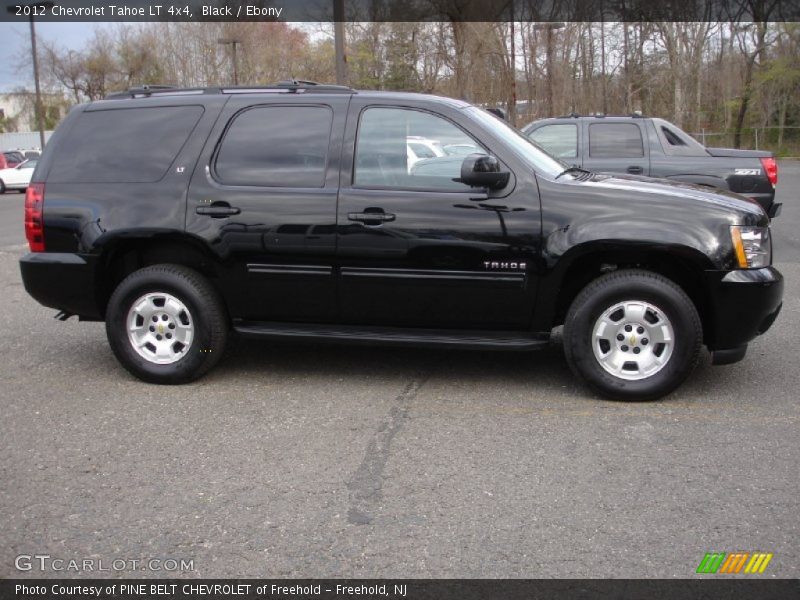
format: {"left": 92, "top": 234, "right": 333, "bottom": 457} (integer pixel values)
{"left": 97, "top": 238, "right": 219, "bottom": 315}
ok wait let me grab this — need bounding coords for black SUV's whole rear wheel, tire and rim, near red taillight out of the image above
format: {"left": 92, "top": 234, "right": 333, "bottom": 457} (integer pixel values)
{"left": 106, "top": 264, "right": 229, "bottom": 384}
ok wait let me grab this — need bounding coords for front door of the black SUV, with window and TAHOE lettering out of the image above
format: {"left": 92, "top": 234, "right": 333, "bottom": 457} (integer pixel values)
{"left": 337, "top": 96, "right": 540, "bottom": 329}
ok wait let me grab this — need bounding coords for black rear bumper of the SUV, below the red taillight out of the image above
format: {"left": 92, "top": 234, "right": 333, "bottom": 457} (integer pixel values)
{"left": 19, "top": 252, "right": 102, "bottom": 319}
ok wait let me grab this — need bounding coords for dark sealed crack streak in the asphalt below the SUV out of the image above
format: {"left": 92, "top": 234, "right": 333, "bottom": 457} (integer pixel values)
{"left": 347, "top": 373, "right": 430, "bottom": 525}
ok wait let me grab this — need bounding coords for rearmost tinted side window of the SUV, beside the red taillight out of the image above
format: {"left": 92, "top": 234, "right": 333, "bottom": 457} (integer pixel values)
{"left": 48, "top": 106, "right": 203, "bottom": 183}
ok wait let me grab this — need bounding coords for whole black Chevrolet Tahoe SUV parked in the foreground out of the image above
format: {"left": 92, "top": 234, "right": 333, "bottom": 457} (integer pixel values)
{"left": 21, "top": 82, "right": 783, "bottom": 400}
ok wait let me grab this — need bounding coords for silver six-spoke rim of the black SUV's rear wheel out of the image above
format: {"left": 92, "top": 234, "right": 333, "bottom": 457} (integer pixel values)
{"left": 126, "top": 292, "right": 194, "bottom": 365}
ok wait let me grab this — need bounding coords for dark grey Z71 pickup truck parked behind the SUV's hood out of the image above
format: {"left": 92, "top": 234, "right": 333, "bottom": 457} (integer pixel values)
{"left": 522, "top": 115, "right": 781, "bottom": 218}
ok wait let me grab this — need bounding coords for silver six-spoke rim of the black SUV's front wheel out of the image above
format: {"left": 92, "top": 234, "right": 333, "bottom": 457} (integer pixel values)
{"left": 592, "top": 300, "right": 675, "bottom": 381}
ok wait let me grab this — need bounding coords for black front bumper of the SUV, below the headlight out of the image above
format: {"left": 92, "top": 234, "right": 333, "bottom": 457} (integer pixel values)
{"left": 706, "top": 267, "right": 783, "bottom": 354}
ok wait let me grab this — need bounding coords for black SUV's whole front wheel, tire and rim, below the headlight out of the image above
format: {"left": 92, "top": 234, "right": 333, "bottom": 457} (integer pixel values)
{"left": 564, "top": 269, "right": 703, "bottom": 400}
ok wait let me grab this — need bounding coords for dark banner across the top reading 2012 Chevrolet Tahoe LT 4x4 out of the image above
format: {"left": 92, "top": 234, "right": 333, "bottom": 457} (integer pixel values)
{"left": 0, "top": 0, "right": 800, "bottom": 22}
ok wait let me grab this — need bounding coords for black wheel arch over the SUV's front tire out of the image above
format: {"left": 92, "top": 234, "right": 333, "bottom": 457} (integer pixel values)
{"left": 553, "top": 250, "right": 712, "bottom": 341}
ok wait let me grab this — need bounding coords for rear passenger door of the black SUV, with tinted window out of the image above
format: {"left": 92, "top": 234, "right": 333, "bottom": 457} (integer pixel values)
{"left": 186, "top": 93, "right": 350, "bottom": 322}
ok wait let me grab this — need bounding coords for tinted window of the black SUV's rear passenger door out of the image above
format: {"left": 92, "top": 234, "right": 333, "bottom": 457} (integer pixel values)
{"left": 215, "top": 106, "right": 333, "bottom": 187}
